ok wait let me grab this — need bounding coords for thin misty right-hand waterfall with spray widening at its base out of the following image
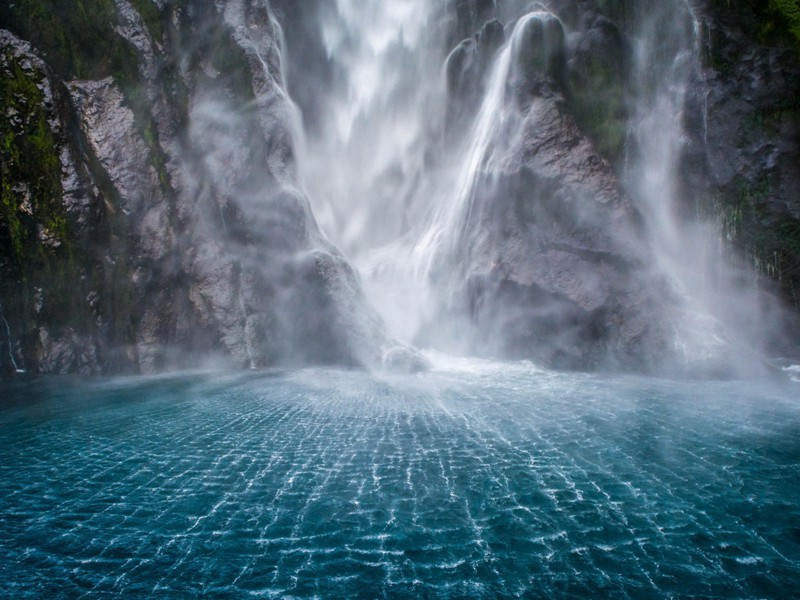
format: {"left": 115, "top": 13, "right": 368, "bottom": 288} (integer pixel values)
{"left": 625, "top": 0, "right": 771, "bottom": 368}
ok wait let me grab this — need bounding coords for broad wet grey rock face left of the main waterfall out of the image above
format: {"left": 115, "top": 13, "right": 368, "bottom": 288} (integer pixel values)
{"left": 0, "top": 0, "right": 395, "bottom": 374}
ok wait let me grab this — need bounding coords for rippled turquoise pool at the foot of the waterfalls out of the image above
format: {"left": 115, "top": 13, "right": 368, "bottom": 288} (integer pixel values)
{"left": 0, "top": 362, "right": 800, "bottom": 598}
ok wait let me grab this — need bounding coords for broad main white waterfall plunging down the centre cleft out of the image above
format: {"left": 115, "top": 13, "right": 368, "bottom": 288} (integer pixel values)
{"left": 299, "top": 0, "right": 445, "bottom": 341}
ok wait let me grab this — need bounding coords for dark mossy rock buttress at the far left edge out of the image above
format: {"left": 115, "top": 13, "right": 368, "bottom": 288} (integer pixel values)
{"left": 0, "top": 31, "right": 110, "bottom": 373}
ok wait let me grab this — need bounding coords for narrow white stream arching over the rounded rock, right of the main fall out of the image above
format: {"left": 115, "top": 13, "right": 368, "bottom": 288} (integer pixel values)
{"left": 362, "top": 10, "right": 564, "bottom": 351}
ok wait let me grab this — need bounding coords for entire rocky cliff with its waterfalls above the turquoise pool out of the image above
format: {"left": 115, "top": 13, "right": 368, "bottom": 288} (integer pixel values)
{"left": 0, "top": 0, "right": 800, "bottom": 375}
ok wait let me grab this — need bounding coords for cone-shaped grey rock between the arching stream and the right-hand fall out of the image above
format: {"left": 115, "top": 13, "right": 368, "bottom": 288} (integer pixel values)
{"left": 438, "top": 95, "right": 669, "bottom": 370}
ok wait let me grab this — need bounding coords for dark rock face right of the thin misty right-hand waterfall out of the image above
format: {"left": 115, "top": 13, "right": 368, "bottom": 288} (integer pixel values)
{"left": 684, "top": 1, "right": 800, "bottom": 310}
